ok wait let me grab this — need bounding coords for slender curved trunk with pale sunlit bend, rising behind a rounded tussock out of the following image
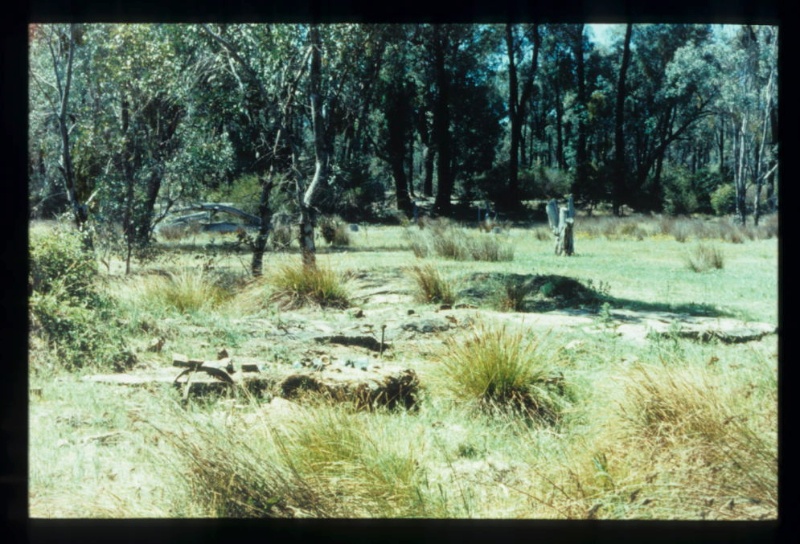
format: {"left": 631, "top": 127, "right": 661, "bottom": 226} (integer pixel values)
{"left": 300, "top": 24, "right": 328, "bottom": 268}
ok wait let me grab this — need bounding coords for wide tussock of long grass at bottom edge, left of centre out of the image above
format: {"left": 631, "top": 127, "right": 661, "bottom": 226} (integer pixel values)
{"left": 162, "top": 402, "right": 425, "bottom": 518}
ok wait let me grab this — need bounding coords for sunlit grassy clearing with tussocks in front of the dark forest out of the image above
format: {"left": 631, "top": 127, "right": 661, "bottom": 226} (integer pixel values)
{"left": 29, "top": 218, "right": 778, "bottom": 520}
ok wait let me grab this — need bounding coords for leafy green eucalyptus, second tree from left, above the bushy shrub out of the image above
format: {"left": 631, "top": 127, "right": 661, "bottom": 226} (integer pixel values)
{"left": 88, "top": 24, "right": 230, "bottom": 270}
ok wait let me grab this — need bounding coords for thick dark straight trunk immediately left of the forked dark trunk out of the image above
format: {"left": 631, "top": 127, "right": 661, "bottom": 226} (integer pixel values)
{"left": 433, "top": 25, "right": 453, "bottom": 216}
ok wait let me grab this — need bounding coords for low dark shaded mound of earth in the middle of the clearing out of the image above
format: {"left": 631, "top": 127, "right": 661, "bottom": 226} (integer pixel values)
{"left": 458, "top": 272, "right": 604, "bottom": 312}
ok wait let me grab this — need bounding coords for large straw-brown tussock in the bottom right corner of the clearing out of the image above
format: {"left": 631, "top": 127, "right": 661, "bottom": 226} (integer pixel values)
{"left": 618, "top": 364, "right": 778, "bottom": 515}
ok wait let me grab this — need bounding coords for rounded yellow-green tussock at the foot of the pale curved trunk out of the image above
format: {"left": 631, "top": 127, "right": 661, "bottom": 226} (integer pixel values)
{"left": 268, "top": 262, "right": 350, "bottom": 308}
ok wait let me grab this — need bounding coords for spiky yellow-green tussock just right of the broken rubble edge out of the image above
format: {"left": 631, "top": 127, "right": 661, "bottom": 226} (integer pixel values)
{"left": 440, "top": 325, "right": 567, "bottom": 424}
